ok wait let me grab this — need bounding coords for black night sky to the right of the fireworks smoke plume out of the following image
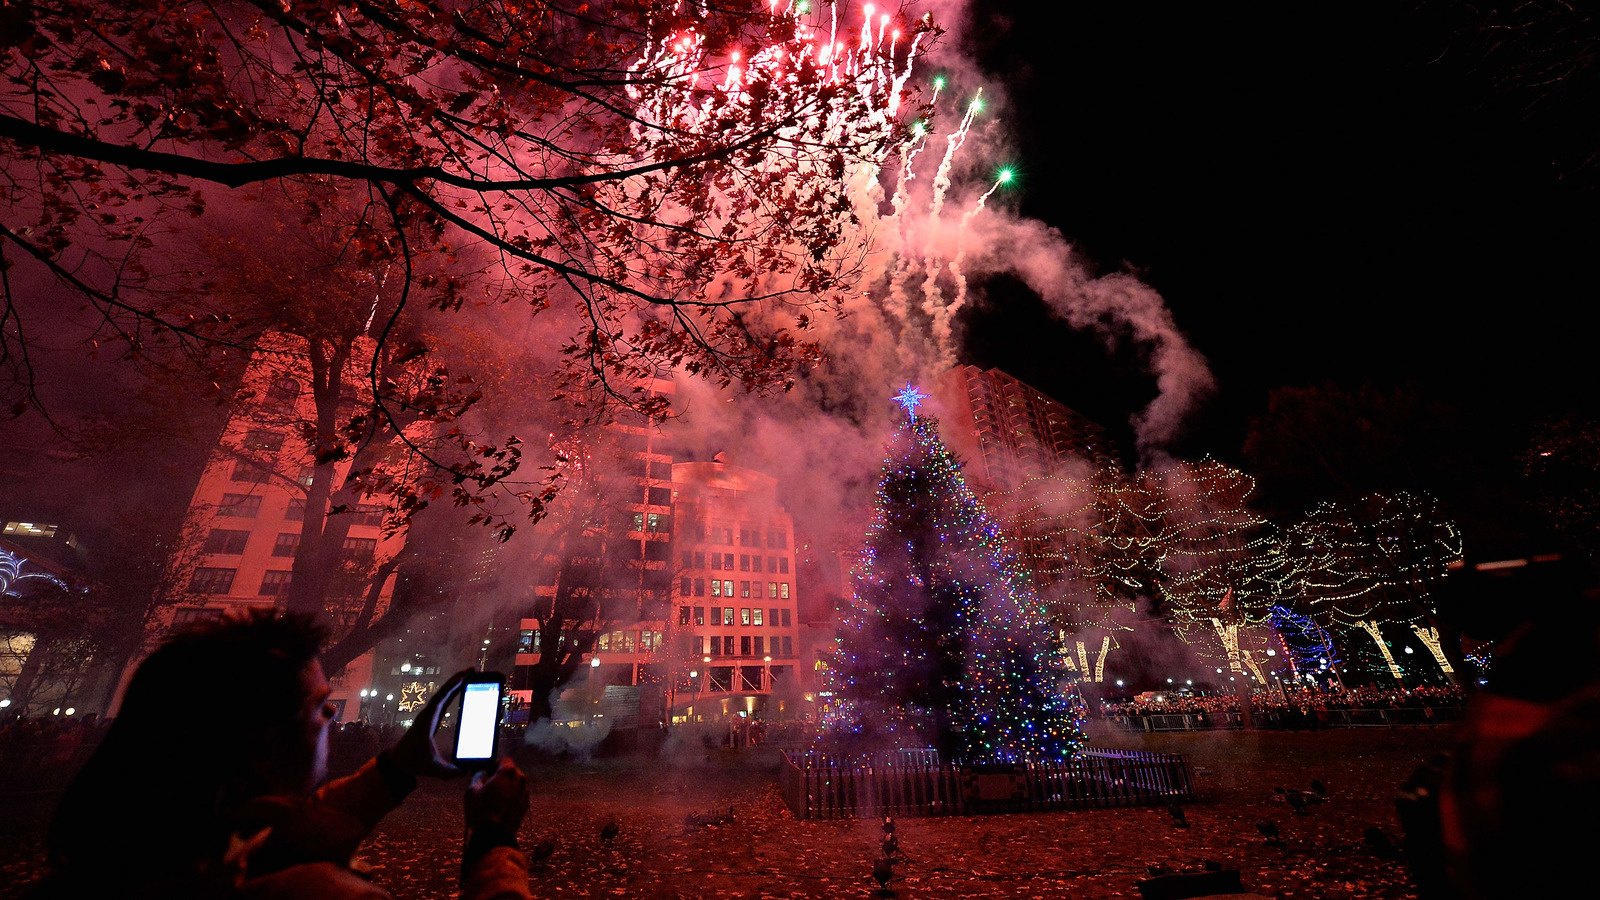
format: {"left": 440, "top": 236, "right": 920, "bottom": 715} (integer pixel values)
{"left": 965, "top": 3, "right": 1600, "bottom": 458}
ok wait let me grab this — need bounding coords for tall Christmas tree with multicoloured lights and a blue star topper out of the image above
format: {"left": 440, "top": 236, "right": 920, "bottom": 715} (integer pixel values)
{"left": 827, "top": 384, "right": 1083, "bottom": 762}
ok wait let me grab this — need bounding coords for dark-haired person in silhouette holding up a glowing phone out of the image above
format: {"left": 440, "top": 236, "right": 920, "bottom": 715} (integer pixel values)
{"left": 32, "top": 612, "right": 530, "bottom": 900}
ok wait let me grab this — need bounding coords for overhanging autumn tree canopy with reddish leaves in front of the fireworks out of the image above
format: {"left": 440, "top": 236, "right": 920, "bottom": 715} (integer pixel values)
{"left": 0, "top": 0, "right": 933, "bottom": 527}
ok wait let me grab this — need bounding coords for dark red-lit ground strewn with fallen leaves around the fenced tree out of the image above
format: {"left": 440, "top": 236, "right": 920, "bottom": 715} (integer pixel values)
{"left": 0, "top": 729, "right": 1450, "bottom": 900}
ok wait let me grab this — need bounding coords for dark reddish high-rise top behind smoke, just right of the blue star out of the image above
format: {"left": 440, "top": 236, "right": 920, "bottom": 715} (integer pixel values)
{"left": 933, "top": 365, "right": 1114, "bottom": 492}
